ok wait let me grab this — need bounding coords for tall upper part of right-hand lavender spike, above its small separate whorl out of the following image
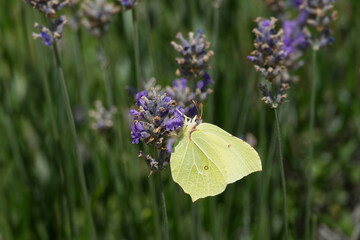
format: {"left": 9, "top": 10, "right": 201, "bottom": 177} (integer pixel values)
{"left": 248, "top": 17, "right": 287, "bottom": 82}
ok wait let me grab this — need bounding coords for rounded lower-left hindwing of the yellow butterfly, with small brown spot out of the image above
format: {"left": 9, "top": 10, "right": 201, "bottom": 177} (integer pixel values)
{"left": 170, "top": 128, "right": 227, "bottom": 202}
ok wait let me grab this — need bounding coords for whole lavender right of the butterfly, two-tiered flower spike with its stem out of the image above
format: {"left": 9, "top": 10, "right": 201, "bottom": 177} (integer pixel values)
{"left": 248, "top": 15, "right": 289, "bottom": 239}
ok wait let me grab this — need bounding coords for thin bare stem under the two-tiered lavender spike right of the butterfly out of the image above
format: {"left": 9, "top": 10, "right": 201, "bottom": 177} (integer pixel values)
{"left": 274, "top": 108, "right": 289, "bottom": 240}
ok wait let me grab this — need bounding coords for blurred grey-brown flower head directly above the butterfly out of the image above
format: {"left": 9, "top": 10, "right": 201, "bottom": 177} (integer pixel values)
{"left": 171, "top": 31, "right": 214, "bottom": 79}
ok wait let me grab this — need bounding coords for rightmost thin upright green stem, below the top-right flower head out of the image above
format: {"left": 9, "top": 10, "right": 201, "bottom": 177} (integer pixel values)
{"left": 305, "top": 50, "right": 317, "bottom": 239}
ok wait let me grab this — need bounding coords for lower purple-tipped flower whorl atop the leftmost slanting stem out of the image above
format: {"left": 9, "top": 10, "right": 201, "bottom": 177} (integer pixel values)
{"left": 32, "top": 16, "right": 67, "bottom": 46}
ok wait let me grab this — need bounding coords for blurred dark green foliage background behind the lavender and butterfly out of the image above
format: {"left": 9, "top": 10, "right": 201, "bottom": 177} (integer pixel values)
{"left": 0, "top": 0, "right": 360, "bottom": 240}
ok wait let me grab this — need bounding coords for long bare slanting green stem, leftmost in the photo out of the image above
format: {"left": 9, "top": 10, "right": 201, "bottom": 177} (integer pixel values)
{"left": 53, "top": 42, "right": 97, "bottom": 239}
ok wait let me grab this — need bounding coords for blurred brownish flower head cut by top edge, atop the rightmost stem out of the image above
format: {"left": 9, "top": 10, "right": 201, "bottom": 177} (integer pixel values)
{"left": 299, "top": 0, "right": 338, "bottom": 50}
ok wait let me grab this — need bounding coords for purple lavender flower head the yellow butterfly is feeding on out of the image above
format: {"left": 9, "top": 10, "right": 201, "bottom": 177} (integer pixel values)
{"left": 130, "top": 89, "right": 184, "bottom": 172}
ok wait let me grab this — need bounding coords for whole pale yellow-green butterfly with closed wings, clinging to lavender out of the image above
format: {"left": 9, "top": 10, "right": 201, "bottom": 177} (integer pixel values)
{"left": 170, "top": 113, "right": 262, "bottom": 202}
